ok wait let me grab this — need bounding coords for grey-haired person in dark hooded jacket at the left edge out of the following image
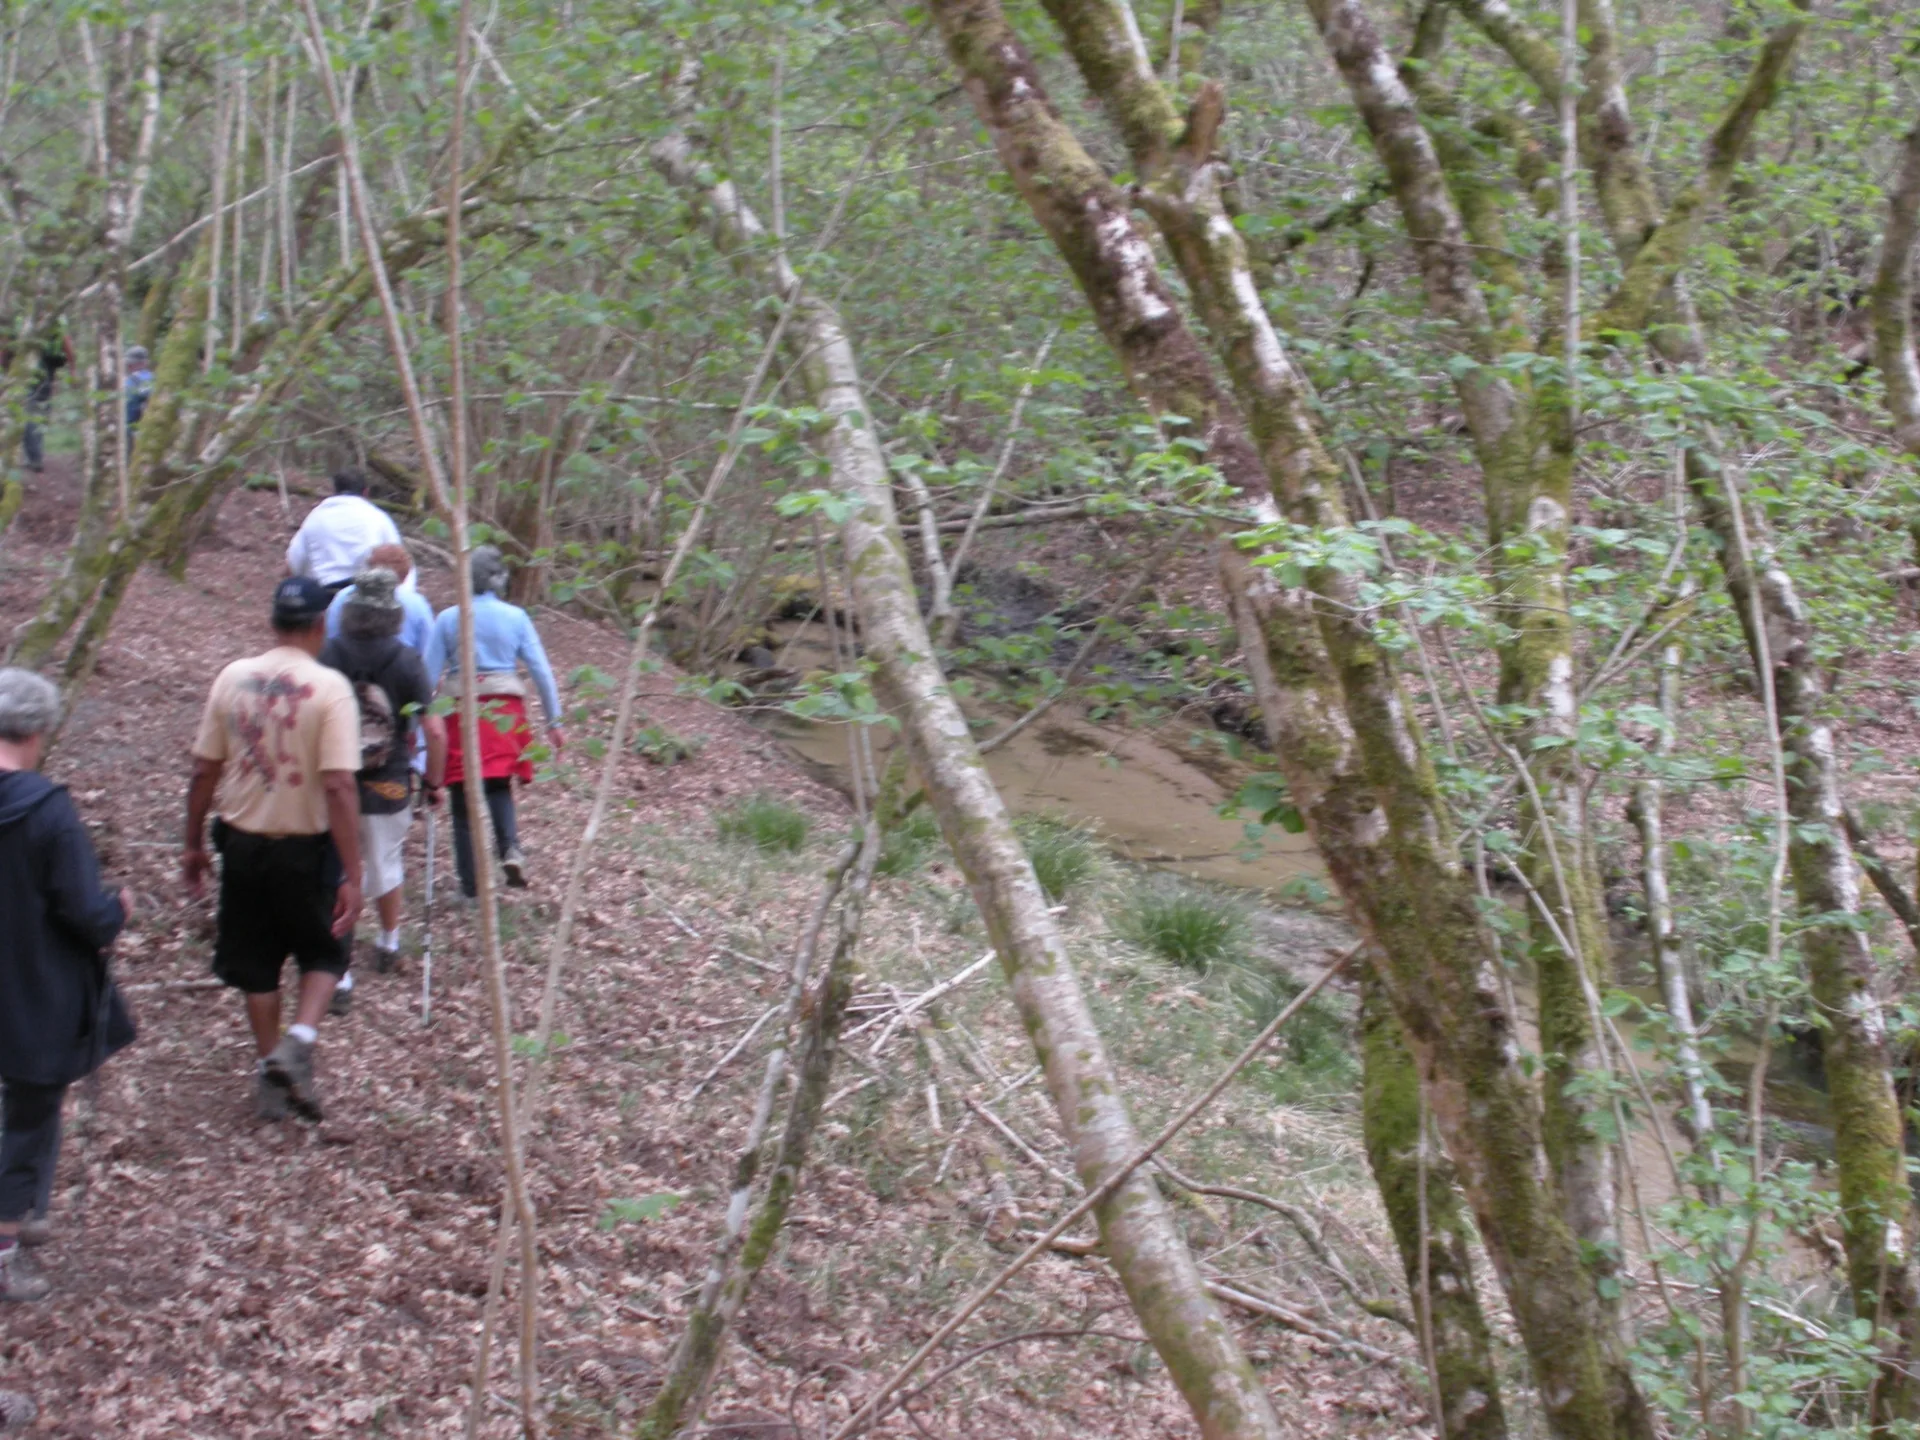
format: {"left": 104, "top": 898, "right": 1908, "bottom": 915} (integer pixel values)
{"left": 0, "top": 668, "right": 132, "bottom": 1300}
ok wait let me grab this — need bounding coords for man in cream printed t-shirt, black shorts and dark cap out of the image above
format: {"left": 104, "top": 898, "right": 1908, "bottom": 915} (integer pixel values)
{"left": 180, "top": 576, "right": 361, "bottom": 1119}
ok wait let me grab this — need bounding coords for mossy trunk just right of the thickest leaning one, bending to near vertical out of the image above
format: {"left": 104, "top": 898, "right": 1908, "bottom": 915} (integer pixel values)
{"left": 1309, "top": 0, "right": 1620, "bottom": 1306}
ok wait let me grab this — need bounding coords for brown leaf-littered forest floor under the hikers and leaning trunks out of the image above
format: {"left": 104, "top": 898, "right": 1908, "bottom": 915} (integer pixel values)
{"left": 0, "top": 465, "right": 1425, "bottom": 1440}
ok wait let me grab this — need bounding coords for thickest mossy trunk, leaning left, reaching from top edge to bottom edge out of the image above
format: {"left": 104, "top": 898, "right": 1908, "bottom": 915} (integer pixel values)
{"left": 935, "top": 0, "right": 1651, "bottom": 1440}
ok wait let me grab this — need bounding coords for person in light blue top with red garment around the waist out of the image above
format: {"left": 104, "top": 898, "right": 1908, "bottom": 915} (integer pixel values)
{"left": 434, "top": 545, "right": 566, "bottom": 899}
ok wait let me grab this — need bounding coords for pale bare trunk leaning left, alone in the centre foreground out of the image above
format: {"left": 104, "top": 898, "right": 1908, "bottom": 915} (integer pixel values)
{"left": 655, "top": 93, "right": 1281, "bottom": 1440}
